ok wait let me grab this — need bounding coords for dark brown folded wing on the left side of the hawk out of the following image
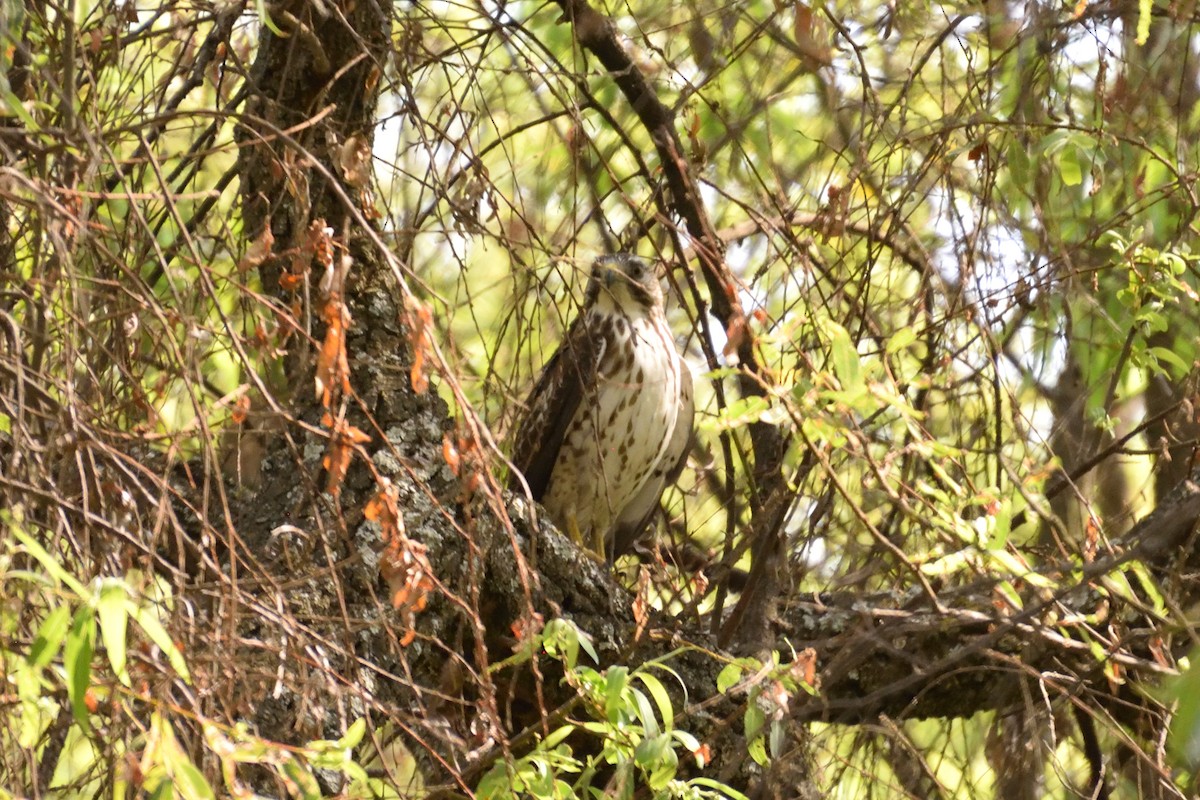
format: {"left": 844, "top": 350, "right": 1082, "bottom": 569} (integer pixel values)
{"left": 509, "top": 313, "right": 607, "bottom": 501}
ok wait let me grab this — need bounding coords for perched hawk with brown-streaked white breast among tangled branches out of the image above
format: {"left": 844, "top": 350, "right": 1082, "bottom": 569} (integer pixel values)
{"left": 510, "top": 253, "right": 695, "bottom": 560}
